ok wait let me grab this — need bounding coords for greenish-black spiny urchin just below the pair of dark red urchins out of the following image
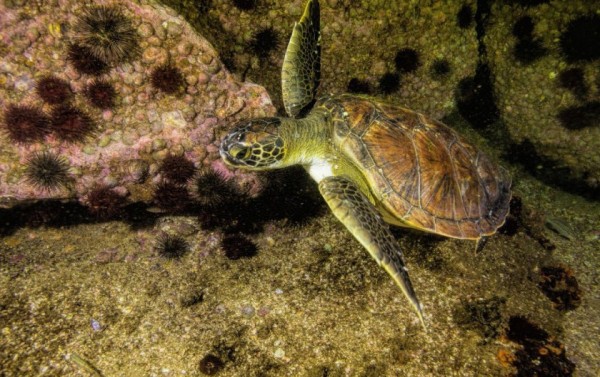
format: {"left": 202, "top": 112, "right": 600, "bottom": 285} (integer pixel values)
{"left": 25, "top": 152, "right": 69, "bottom": 191}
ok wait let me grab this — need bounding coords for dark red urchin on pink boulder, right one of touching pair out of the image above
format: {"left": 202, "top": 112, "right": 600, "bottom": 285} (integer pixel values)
{"left": 51, "top": 105, "right": 95, "bottom": 142}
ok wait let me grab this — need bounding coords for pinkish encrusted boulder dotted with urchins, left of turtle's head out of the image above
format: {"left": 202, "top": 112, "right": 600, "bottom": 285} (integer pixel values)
{"left": 0, "top": 0, "right": 275, "bottom": 207}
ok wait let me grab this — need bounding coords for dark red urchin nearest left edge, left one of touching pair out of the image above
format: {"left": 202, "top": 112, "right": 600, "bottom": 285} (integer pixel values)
{"left": 4, "top": 105, "right": 50, "bottom": 143}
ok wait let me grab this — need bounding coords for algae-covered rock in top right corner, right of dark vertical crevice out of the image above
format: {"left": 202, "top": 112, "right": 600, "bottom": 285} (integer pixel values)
{"left": 485, "top": 1, "right": 600, "bottom": 188}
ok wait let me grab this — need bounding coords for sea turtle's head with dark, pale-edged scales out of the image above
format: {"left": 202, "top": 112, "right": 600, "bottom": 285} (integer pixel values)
{"left": 219, "top": 118, "right": 286, "bottom": 170}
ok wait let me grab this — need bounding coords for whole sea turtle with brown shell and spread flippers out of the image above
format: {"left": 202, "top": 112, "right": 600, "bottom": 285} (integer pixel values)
{"left": 220, "top": 0, "right": 511, "bottom": 325}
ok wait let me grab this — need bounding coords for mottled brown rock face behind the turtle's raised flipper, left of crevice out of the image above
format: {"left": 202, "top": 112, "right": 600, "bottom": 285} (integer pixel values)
{"left": 186, "top": 0, "right": 478, "bottom": 119}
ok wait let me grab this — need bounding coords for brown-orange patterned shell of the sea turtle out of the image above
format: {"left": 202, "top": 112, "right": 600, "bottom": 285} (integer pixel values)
{"left": 322, "top": 95, "right": 511, "bottom": 239}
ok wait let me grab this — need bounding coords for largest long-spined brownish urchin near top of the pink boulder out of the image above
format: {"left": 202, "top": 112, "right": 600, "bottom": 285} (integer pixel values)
{"left": 73, "top": 6, "right": 140, "bottom": 65}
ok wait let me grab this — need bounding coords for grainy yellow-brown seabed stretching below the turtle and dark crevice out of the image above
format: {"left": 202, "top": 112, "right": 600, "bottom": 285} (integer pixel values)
{"left": 0, "top": 166, "right": 600, "bottom": 376}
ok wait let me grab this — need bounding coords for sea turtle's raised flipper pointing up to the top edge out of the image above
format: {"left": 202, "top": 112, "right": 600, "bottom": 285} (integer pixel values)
{"left": 281, "top": 0, "right": 321, "bottom": 118}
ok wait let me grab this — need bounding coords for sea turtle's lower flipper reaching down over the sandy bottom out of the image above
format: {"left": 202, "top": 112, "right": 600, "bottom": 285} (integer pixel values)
{"left": 319, "top": 177, "right": 425, "bottom": 327}
